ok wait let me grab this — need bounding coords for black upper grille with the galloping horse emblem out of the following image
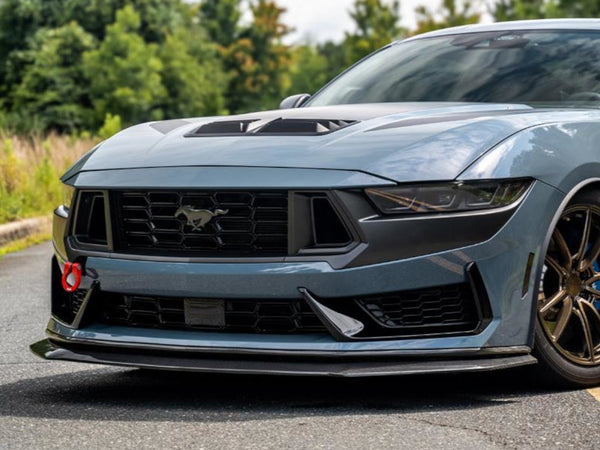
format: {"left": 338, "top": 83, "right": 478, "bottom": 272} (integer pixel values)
{"left": 115, "top": 191, "right": 288, "bottom": 257}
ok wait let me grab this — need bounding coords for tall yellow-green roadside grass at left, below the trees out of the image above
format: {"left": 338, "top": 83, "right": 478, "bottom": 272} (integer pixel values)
{"left": 0, "top": 131, "right": 96, "bottom": 224}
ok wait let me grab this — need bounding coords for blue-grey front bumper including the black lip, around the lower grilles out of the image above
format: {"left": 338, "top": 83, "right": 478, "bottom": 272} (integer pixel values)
{"left": 37, "top": 178, "right": 563, "bottom": 376}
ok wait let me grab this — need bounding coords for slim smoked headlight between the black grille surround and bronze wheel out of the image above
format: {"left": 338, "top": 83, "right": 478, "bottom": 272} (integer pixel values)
{"left": 365, "top": 179, "right": 531, "bottom": 214}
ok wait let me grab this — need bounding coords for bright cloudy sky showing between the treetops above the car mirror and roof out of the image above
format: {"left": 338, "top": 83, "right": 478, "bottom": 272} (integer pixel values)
{"left": 277, "top": 0, "right": 492, "bottom": 44}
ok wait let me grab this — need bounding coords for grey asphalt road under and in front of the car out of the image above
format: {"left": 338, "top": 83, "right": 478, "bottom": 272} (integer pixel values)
{"left": 0, "top": 244, "right": 600, "bottom": 450}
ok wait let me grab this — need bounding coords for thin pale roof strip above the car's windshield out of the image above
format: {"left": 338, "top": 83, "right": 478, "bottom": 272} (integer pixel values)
{"left": 400, "top": 19, "right": 600, "bottom": 41}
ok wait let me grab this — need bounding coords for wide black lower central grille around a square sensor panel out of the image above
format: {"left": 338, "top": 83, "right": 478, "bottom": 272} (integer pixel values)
{"left": 97, "top": 293, "right": 325, "bottom": 334}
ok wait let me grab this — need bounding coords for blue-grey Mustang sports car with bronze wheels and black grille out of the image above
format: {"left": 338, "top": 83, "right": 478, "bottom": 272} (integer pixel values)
{"left": 31, "top": 20, "right": 600, "bottom": 385}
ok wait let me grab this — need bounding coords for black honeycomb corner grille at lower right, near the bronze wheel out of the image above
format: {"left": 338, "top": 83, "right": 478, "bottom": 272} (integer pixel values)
{"left": 358, "top": 283, "right": 480, "bottom": 333}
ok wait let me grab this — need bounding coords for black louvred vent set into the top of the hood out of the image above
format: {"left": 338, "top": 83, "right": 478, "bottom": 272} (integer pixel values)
{"left": 185, "top": 118, "right": 358, "bottom": 137}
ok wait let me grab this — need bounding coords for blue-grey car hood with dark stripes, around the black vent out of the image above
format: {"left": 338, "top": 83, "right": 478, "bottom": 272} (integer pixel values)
{"left": 69, "top": 103, "right": 596, "bottom": 182}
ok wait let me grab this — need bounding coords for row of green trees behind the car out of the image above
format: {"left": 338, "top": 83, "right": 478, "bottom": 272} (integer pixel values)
{"left": 5, "top": 0, "right": 600, "bottom": 135}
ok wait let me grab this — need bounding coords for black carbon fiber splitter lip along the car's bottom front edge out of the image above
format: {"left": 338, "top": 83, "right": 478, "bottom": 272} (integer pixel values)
{"left": 30, "top": 339, "right": 537, "bottom": 377}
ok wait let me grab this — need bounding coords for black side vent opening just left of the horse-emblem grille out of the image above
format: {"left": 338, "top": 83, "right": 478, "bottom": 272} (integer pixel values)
{"left": 73, "top": 191, "right": 108, "bottom": 247}
